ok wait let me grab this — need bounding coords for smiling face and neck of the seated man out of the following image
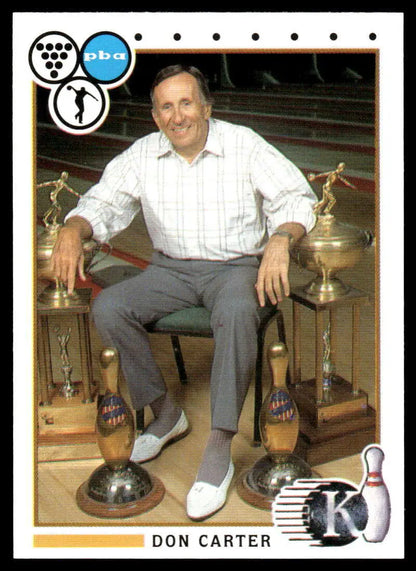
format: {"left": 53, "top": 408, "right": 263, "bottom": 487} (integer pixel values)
{"left": 152, "top": 72, "right": 211, "bottom": 162}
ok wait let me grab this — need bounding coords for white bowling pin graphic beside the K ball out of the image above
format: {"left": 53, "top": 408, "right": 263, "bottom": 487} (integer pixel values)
{"left": 361, "top": 445, "right": 390, "bottom": 543}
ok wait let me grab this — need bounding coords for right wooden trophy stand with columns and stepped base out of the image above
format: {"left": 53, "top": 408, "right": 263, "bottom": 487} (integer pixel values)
{"left": 289, "top": 287, "right": 375, "bottom": 465}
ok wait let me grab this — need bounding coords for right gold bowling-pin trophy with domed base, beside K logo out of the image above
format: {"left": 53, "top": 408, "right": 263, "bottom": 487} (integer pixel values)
{"left": 237, "top": 343, "right": 316, "bottom": 510}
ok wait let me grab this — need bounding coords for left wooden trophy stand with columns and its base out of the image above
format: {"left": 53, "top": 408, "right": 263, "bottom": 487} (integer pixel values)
{"left": 37, "top": 288, "right": 97, "bottom": 443}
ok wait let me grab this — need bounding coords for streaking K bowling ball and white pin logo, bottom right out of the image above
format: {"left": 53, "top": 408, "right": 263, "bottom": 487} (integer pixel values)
{"left": 272, "top": 444, "right": 391, "bottom": 547}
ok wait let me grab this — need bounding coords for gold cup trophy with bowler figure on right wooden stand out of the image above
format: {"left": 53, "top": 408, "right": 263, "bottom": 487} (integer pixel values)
{"left": 291, "top": 163, "right": 373, "bottom": 301}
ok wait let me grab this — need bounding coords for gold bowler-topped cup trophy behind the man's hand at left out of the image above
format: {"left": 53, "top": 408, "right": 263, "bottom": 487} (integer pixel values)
{"left": 36, "top": 171, "right": 100, "bottom": 307}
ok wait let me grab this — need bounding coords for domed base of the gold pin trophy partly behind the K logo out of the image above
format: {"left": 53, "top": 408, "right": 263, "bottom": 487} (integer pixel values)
{"left": 237, "top": 454, "right": 319, "bottom": 510}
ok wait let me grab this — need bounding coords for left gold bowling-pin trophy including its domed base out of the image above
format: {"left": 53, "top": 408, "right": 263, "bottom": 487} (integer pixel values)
{"left": 76, "top": 347, "right": 165, "bottom": 518}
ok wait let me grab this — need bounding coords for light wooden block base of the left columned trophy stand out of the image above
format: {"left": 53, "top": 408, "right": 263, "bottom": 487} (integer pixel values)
{"left": 37, "top": 383, "right": 97, "bottom": 445}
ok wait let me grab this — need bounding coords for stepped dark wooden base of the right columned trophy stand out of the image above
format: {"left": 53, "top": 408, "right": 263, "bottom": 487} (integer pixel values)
{"left": 289, "top": 377, "right": 376, "bottom": 466}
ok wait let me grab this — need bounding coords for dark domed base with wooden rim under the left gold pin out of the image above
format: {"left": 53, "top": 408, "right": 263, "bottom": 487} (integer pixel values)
{"left": 76, "top": 461, "right": 165, "bottom": 518}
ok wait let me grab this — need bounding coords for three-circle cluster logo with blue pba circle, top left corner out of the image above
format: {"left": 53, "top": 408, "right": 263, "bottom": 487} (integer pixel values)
{"left": 29, "top": 32, "right": 134, "bottom": 134}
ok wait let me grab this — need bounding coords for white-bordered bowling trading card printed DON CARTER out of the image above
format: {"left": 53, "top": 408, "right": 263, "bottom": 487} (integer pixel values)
{"left": 13, "top": 12, "right": 405, "bottom": 560}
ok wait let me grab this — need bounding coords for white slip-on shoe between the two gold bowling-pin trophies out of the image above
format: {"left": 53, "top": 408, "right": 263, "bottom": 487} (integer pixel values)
{"left": 186, "top": 461, "right": 234, "bottom": 520}
